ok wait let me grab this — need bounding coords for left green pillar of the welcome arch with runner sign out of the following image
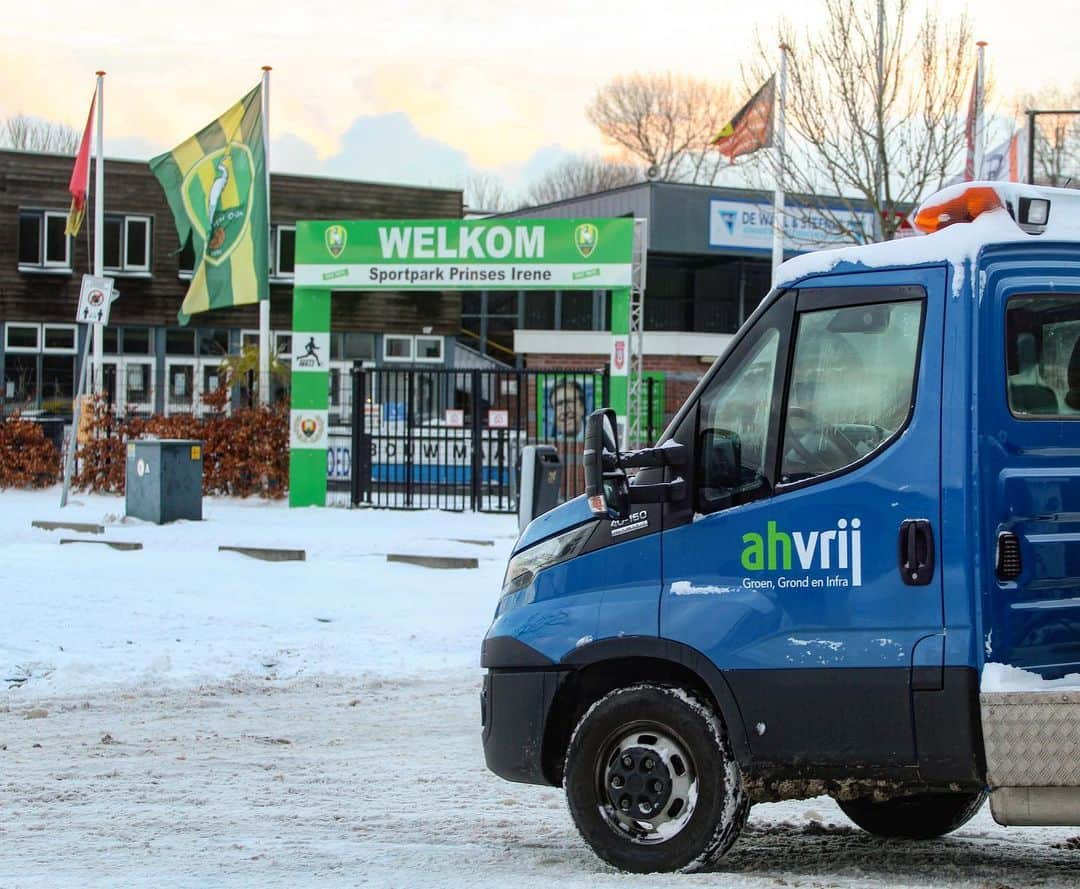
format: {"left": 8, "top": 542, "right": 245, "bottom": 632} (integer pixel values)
{"left": 288, "top": 287, "right": 330, "bottom": 507}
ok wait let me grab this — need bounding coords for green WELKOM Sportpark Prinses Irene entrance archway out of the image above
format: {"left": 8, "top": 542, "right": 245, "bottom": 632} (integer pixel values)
{"left": 288, "top": 218, "right": 644, "bottom": 507}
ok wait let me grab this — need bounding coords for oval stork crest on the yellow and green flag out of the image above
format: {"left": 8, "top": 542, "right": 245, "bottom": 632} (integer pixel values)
{"left": 180, "top": 142, "right": 255, "bottom": 266}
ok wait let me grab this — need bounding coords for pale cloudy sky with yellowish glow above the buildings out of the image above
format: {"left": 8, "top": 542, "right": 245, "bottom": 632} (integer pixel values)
{"left": 0, "top": 0, "right": 1080, "bottom": 193}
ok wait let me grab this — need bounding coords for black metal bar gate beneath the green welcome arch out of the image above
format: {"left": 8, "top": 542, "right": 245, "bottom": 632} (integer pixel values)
{"left": 349, "top": 362, "right": 657, "bottom": 512}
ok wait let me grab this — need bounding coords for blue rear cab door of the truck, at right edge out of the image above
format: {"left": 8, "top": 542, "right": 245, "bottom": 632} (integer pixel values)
{"left": 978, "top": 260, "right": 1080, "bottom": 678}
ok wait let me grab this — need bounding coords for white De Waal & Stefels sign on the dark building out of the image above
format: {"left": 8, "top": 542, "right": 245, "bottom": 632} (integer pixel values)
{"left": 708, "top": 200, "right": 874, "bottom": 253}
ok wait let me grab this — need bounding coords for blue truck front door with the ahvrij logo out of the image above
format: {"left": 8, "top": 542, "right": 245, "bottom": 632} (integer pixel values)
{"left": 661, "top": 268, "right": 946, "bottom": 768}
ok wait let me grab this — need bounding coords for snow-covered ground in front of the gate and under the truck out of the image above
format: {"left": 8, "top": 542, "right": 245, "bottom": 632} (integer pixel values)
{"left": 0, "top": 491, "right": 1080, "bottom": 889}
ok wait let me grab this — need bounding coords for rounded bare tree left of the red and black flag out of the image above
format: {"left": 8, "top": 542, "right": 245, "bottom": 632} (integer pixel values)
{"left": 585, "top": 72, "right": 733, "bottom": 184}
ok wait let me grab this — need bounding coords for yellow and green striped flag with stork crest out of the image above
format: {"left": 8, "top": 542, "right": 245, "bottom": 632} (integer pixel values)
{"left": 150, "top": 85, "right": 269, "bottom": 324}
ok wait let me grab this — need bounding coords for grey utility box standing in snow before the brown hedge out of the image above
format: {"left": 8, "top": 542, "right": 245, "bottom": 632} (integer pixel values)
{"left": 124, "top": 439, "right": 202, "bottom": 525}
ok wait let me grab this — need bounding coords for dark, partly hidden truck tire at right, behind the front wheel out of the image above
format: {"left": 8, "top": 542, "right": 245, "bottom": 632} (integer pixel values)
{"left": 836, "top": 792, "right": 986, "bottom": 839}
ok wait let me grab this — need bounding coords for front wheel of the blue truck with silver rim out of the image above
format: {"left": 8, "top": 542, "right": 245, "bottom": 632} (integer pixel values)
{"left": 564, "top": 684, "right": 750, "bottom": 874}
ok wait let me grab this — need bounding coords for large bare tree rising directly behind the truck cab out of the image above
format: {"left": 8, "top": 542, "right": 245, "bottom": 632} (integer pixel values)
{"left": 744, "top": 0, "right": 975, "bottom": 243}
